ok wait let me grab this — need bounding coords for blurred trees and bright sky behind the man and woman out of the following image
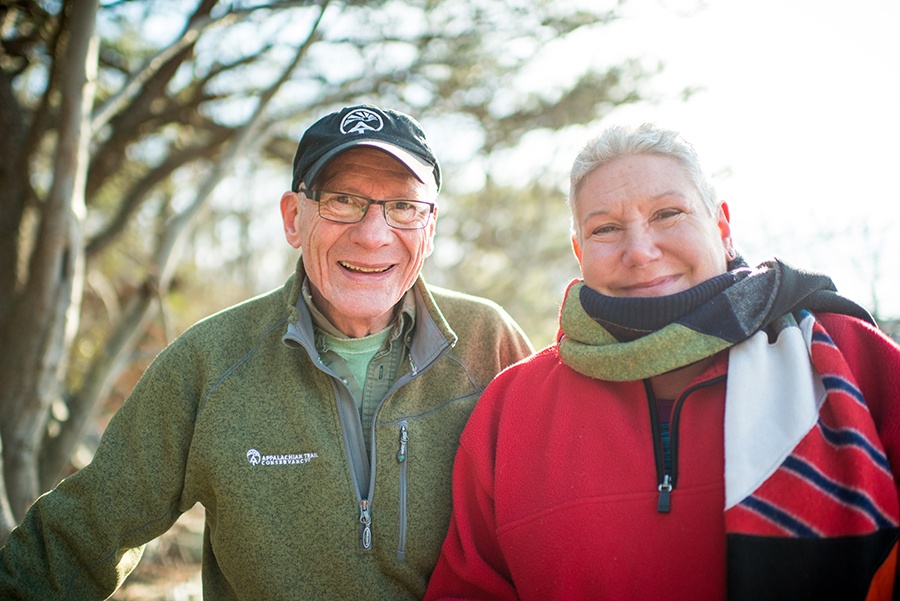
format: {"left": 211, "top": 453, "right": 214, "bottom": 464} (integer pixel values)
{"left": 0, "top": 0, "right": 900, "bottom": 600}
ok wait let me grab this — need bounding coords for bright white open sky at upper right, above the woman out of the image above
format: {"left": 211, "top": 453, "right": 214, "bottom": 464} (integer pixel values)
{"left": 584, "top": 0, "right": 900, "bottom": 317}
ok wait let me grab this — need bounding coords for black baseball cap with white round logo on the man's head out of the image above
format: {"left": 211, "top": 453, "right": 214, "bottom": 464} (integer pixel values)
{"left": 291, "top": 104, "right": 441, "bottom": 192}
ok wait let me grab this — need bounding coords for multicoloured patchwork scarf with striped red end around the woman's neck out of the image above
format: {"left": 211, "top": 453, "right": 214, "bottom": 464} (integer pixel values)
{"left": 559, "top": 260, "right": 900, "bottom": 601}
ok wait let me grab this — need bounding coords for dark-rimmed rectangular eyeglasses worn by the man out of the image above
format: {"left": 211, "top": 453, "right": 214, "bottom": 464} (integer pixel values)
{"left": 298, "top": 188, "right": 434, "bottom": 230}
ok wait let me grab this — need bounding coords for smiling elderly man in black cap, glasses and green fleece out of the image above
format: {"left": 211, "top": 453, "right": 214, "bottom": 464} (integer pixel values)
{"left": 0, "top": 106, "right": 532, "bottom": 601}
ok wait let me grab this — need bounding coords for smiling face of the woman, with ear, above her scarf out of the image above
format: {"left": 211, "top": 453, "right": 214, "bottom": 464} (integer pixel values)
{"left": 572, "top": 155, "right": 731, "bottom": 297}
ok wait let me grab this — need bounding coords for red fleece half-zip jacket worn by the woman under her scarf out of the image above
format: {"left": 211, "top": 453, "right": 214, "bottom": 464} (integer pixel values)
{"left": 426, "top": 314, "right": 900, "bottom": 601}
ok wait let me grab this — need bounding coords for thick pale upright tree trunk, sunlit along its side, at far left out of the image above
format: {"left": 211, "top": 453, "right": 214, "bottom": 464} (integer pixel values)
{"left": 0, "top": 0, "right": 99, "bottom": 520}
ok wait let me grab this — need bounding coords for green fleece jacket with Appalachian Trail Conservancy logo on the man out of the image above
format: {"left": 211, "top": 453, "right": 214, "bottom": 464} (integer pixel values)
{"left": 0, "top": 262, "right": 532, "bottom": 601}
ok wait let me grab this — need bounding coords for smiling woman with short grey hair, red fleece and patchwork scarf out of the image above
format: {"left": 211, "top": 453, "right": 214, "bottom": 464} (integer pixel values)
{"left": 426, "top": 125, "right": 900, "bottom": 601}
